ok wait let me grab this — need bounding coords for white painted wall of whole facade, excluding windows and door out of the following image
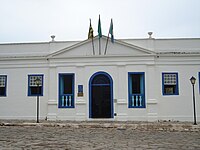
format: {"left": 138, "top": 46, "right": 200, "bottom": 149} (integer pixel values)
{"left": 0, "top": 39, "right": 200, "bottom": 121}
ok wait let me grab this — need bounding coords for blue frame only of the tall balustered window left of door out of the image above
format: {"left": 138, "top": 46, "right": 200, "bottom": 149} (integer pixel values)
{"left": 58, "top": 73, "right": 75, "bottom": 108}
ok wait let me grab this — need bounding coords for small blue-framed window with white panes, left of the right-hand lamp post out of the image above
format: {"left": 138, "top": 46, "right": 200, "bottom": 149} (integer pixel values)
{"left": 162, "top": 73, "right": 179, "bottom": 95}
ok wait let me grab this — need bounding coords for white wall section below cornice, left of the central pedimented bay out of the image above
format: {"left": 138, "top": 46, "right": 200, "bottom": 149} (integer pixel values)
{"left": 0, "top": 67, "right": 48, "bottom": 119}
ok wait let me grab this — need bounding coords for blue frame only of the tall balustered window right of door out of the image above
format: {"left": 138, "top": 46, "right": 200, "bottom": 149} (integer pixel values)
{"left": 128, "top": 72, "right": 146, "bottom": 108}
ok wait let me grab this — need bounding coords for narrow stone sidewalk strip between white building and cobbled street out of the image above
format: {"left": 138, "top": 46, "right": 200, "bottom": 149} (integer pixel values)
{"left": 0, "top": 120, "right": 200, "bottom": 132}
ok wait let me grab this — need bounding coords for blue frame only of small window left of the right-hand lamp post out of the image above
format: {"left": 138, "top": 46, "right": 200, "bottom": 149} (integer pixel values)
{"left": 162, "top": 72, "right": 179, "bottom": 96}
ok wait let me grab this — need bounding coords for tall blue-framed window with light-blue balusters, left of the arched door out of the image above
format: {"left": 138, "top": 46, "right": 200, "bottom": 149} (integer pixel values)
{"left": 59, "top": 73, "right": 74, "bottom": 108}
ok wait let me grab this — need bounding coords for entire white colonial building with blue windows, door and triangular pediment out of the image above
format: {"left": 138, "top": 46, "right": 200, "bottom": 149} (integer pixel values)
{"left": 0, "top": 33, "right": 200, "bottom": 121}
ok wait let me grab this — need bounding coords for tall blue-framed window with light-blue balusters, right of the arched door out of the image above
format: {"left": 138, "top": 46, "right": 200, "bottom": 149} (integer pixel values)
{"left": 128, "top": 72, "right": 145, "bottom": 108}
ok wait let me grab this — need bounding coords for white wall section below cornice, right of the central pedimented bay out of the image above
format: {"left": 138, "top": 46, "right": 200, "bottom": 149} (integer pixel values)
{"left": 157, "top": 65, "right": 200, "bottom": 121}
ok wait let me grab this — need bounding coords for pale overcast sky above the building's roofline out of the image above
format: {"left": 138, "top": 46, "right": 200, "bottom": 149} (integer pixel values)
{"left": 0, "top": 0, "right": 200, "bottom": 43}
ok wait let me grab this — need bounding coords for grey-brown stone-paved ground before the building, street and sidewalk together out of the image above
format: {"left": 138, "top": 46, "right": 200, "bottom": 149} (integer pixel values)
{"left": 0, "top": 121, "right": 200, "bottom": 150}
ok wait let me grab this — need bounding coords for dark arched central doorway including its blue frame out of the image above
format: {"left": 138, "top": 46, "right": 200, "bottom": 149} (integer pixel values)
{"left": 89, "top": 72, "right": 113, "bottom": 118}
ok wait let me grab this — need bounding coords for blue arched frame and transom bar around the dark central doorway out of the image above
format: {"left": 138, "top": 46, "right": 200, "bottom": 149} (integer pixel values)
{"left": 89, "top": 71, "right": 114, "bottom": 118}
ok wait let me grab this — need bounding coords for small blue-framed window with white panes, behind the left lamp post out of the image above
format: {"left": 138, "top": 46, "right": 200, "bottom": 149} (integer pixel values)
{"left": 28, "top": 74, "right": 43, "bottom": 96}
